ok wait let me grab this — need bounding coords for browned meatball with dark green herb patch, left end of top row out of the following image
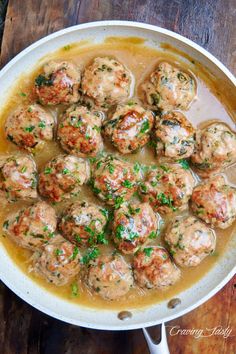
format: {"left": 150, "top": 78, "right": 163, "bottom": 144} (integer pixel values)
{"left": 35, "top": 60, "right": 81, "bottom": 105}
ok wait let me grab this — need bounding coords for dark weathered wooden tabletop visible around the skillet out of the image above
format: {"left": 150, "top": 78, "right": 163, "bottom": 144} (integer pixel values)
{"left": 0, "top": 0, "right": 236, "bottom": 354}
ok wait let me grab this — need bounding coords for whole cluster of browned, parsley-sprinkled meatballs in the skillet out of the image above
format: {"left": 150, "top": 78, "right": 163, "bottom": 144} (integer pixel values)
{"left": 0, "top": 57, "right": 236, "bottom": 300}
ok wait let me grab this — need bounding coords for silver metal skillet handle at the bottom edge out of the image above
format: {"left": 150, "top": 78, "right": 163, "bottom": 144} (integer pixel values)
{"left": 143, "top": 323, "right": 170, "bottom": 354}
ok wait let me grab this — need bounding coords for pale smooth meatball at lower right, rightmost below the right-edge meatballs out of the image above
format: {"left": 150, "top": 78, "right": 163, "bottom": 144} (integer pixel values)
{"left": 165, "top": 216, "right": 216, "bottom": 267}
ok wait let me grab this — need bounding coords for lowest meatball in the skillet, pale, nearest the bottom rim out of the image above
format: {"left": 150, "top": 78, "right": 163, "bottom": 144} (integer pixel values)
{"left": 88, "top": 256, "right": 133, "bottom": 300}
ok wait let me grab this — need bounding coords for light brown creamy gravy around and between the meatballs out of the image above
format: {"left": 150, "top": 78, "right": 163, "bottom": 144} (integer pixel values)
{"left": 0, "top": 37, "right": 236, "bottom": 310}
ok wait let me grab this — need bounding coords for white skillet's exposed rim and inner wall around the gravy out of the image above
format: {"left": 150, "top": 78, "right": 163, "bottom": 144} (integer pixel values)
{"left": 0, "top": 21, "right": 236, "bottom": 330}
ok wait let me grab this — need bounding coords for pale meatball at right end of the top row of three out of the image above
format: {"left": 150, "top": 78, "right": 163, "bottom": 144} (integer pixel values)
{"left": 143, "top": 62, "right": 196, "bottom": 111}
